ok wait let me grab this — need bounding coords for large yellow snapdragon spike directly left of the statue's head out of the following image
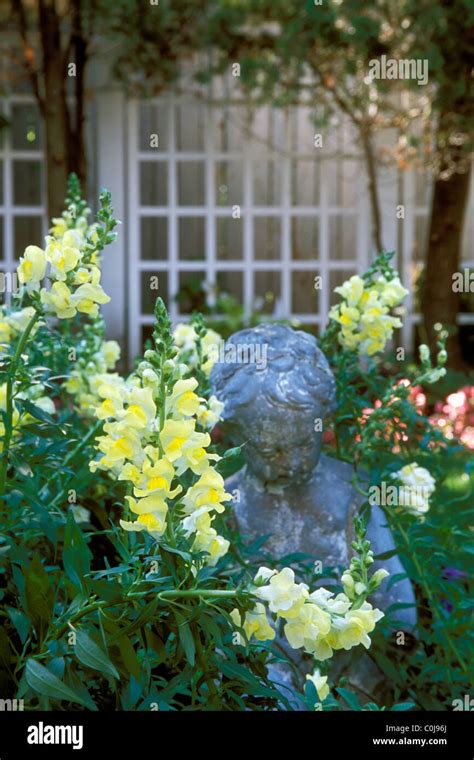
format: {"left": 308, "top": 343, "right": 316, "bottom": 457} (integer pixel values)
{"left": 90, "top": 299, "right": 231, "bottom": 565}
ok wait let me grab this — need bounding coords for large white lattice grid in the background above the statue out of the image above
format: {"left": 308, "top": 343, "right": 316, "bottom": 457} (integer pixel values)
{"left": 127, "top": 94, "right": 371, "bottom": 361}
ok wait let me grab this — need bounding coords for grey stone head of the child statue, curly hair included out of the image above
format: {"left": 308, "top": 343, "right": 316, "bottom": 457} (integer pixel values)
{"left": 211, "top": 325, "right": 336, "bottom": 485}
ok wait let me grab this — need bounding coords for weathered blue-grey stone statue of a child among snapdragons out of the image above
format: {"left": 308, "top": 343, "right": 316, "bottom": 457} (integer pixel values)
{"left": 211, "top": 325, "right": 416, "bottom": 693}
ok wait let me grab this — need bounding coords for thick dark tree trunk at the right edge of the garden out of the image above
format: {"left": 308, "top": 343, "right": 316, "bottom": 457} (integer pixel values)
{"left": 421, "top": 148, "right": 469, "bottom": 369}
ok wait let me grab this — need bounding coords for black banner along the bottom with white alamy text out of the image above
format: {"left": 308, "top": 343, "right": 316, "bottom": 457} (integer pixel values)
{"left": 0, "top": 711, "right": 474, "bottom": 760}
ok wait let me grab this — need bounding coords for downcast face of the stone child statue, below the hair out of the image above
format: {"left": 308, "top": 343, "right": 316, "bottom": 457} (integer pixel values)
{"left": 238, "top": 403, "right": 322, "bottom": 485}
